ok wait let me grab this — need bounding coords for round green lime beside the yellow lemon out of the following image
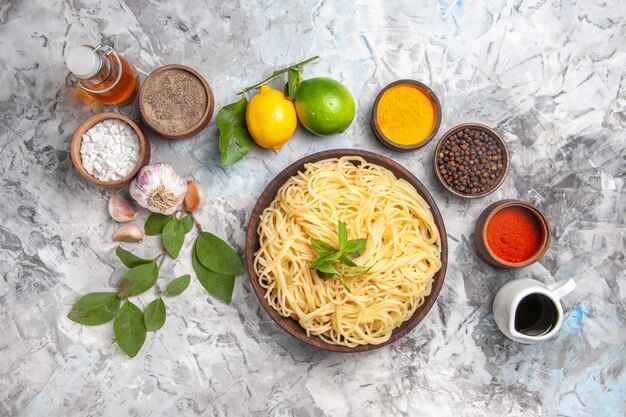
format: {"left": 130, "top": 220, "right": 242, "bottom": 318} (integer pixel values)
{"left": 294, "top": 77, "right": 355, "bottom": 136}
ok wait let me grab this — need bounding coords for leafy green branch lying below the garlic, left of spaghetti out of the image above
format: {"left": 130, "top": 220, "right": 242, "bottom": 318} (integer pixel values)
{"left": 67, "top": 210, "right": 244, "bottom": 357}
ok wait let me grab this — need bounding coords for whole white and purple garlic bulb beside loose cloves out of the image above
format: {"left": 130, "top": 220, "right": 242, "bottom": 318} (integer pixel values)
{"left": 130, "top": 162, "right": 187, "bottom": 214}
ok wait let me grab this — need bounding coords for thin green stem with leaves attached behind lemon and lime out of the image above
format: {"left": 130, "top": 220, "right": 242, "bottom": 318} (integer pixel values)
{"left": 215, "top": 56, "right": 319, "bottom": 166}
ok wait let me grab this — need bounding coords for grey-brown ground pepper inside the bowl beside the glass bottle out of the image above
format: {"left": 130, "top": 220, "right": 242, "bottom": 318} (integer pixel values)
{"left": 143, "top": 69, "right": 208, "bottom": 135}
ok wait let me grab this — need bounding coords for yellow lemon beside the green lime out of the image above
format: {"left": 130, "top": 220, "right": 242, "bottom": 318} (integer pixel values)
{"left": 246, "top": 84, "right": 298, "bottom": 153}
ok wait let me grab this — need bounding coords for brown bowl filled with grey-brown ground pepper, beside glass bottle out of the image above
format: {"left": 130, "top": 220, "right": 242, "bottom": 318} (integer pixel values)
{"left": 139, "top": 65, "right": 214, "bottom": 139}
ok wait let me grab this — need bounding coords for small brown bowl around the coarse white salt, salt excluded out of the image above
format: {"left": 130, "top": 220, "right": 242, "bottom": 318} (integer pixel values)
{"left": 70, "top": 113, "right": 150, "bottom": 188}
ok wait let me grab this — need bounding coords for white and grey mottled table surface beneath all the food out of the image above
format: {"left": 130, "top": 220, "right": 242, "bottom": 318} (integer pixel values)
{"left": 0, "top": 0, "right": 626, "bottom": 417}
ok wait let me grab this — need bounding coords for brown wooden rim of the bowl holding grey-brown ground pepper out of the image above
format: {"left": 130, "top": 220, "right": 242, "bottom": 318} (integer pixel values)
{"left": 139, "top": 64, "right": 215, "bottom": 139}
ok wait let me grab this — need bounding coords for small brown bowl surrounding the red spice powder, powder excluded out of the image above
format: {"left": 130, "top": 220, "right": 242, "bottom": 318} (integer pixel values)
{"left": 474, "top": 200, "right": 552, "bottom": 269}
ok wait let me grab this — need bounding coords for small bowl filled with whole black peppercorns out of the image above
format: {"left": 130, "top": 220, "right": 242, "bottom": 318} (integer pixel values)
{"left": 435, "top": 123, "right": 510, "bottom": 198}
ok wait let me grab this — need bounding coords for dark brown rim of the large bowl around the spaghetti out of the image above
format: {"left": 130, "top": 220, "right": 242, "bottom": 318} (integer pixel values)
{"left": 245, "top": 149, "right": 448, "bottom": 353}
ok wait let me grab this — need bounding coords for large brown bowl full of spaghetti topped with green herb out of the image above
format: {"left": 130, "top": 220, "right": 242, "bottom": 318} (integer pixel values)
{"left": 245, "top": 149, "right": 448, "bottom": 352}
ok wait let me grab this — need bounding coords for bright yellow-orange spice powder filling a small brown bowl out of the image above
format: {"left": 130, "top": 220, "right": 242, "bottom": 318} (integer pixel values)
{"left": 377, "top": 84, "right": 437, "bottom": 145}
